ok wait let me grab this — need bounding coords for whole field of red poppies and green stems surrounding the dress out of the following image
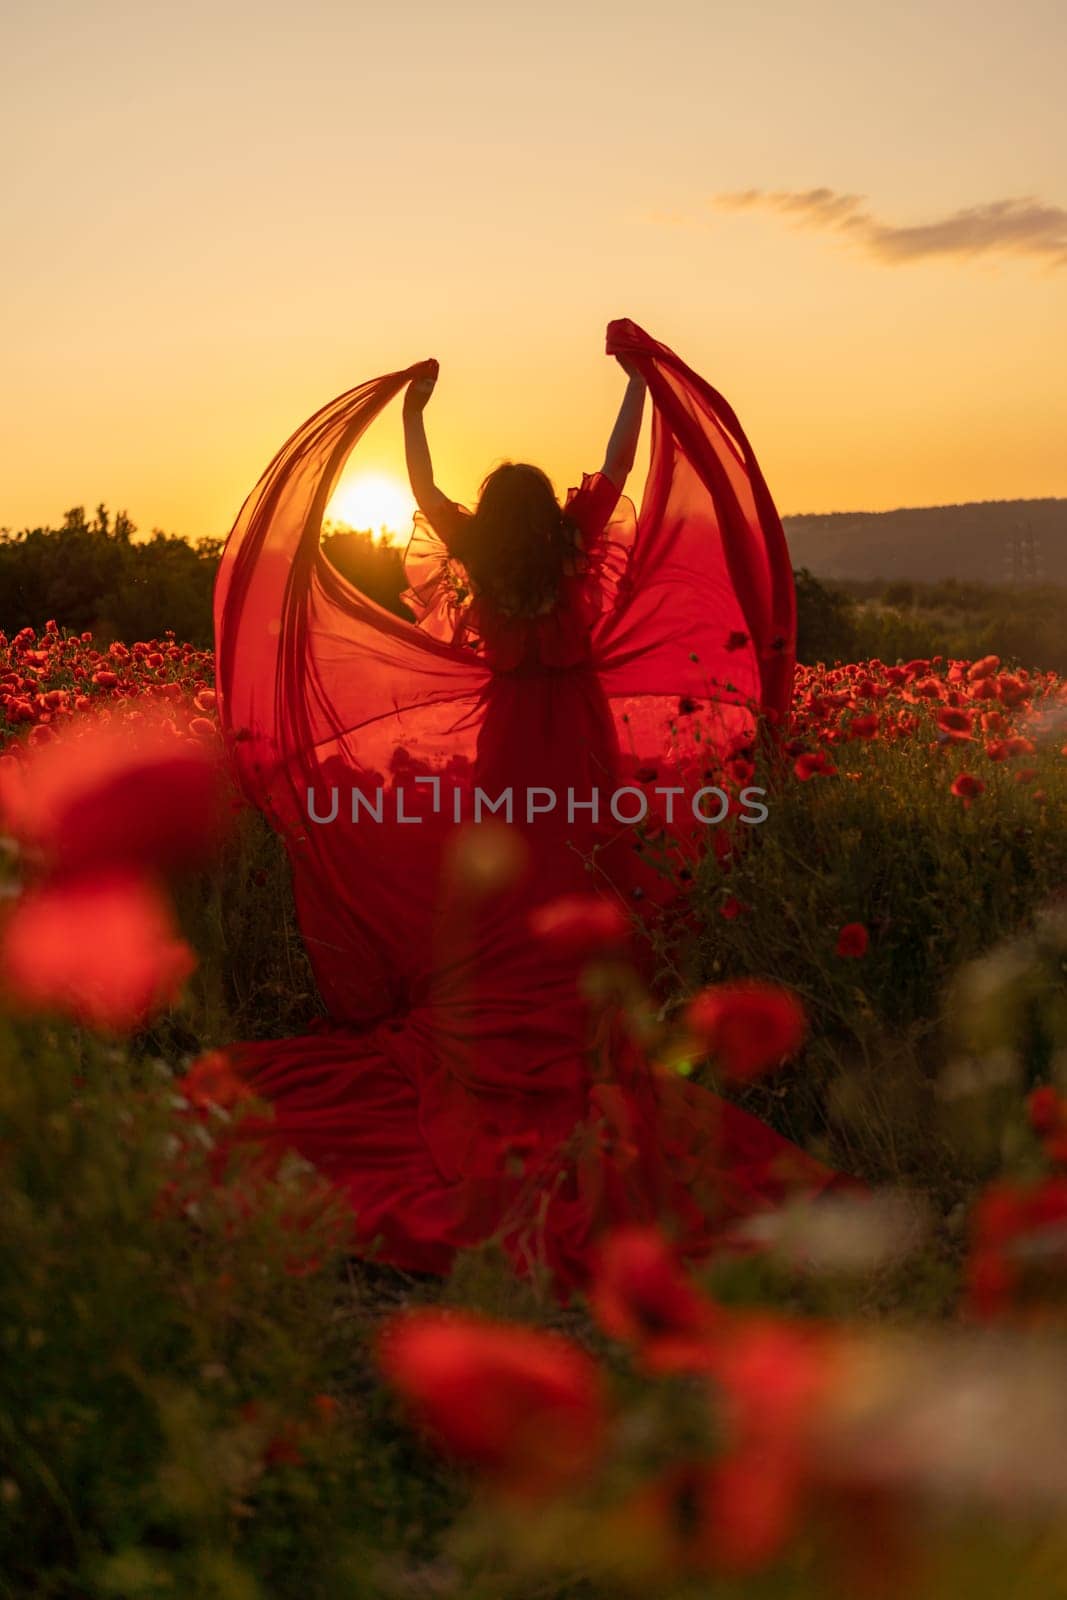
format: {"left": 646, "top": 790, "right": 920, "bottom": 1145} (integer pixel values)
{"left": 0, "top": 624, "right": 1067, "bottom": 1600}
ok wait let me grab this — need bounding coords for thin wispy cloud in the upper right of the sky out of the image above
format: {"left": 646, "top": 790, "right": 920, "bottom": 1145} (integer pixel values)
{"left": 712, "top": 189, "right": 1067, "bottom": 267}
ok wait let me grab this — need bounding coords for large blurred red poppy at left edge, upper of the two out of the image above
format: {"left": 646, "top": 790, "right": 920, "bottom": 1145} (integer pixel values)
{"left": 0, "top": 707, "right": 227, "bottom": 870}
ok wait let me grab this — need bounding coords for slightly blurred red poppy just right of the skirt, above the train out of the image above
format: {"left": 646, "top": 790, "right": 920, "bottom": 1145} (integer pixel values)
{"left": 685, "top": 979, "right": 808, "bottom": 1078}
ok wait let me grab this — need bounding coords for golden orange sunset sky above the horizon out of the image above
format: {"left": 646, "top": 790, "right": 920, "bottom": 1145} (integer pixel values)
{"left": 0, "top": 0, "right": 1067, "bottom": 536}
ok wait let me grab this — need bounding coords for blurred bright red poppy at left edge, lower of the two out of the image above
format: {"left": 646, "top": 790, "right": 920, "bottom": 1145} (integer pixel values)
{"left": 0, "top": 869, "right": 197, "bottom": 1032}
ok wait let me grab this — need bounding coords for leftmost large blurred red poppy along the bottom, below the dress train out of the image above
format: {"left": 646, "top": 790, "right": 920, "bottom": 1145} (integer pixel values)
{"left": 378, "top": 1310, "right": 606, "bottom": 1498}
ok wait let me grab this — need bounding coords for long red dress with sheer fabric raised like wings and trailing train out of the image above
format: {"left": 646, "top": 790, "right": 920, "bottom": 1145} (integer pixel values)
{"left": 216, "top": 322, "right": 832, "bottom": 1291}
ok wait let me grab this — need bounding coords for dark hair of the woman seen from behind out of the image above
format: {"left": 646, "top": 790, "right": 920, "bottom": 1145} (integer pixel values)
{"left": 454, "top": 461, "right": 579, "bottom": 616}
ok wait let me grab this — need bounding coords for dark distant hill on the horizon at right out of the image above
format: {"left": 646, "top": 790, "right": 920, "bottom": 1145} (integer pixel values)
{"left": 782, "top": 499, "right": 1067, "bottom": 584}
